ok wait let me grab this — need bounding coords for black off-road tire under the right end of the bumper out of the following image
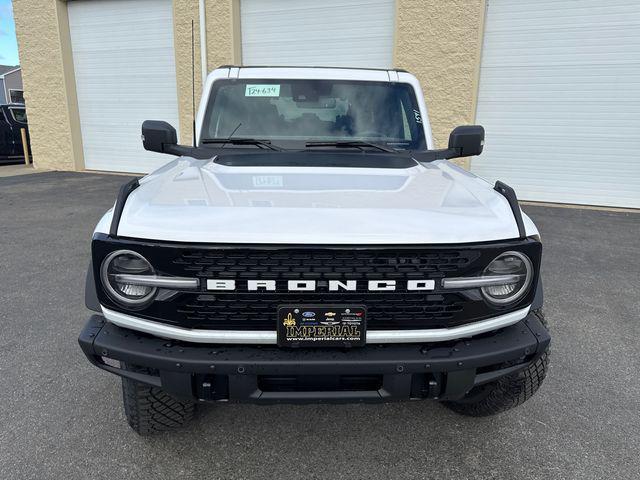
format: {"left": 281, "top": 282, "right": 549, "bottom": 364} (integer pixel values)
{"left": 445, "top": 310, "right": 549, "bottom": 417}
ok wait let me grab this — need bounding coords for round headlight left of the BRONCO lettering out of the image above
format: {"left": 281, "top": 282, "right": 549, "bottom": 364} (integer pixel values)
{"left": 100, "top": 250, "right": 157, "bottom": 306}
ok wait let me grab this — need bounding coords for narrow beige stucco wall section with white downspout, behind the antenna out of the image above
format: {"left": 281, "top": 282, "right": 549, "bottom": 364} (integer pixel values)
{"left": 173, "top": 0, "right": 239, "bottom": 144}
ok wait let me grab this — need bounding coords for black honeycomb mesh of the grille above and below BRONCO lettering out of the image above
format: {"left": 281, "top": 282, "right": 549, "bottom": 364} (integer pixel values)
{"left": 173, "top": 249, "right": 479, "bottom": 330}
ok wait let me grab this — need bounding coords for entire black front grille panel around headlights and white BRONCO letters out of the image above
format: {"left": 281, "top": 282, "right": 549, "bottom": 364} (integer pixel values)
{"left": 93, "top": 236, "right": 540, "bottom": 330}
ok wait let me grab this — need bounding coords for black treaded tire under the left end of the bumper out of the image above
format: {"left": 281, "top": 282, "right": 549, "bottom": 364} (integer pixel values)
{"left": 122, "top": 365, "right": 195, "bottom": 435}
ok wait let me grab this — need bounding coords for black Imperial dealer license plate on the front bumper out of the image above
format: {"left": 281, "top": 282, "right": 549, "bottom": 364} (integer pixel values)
{"left": 277, "top": 305, "right": 367, "bottom": 347}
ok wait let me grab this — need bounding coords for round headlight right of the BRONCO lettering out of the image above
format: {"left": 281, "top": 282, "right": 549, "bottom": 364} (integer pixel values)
{"left": 482, "top": 252, "right": 533, "bottom": 305}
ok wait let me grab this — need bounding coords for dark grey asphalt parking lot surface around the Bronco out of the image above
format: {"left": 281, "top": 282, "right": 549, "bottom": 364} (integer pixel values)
{"left": 0, "top": 172, "right": 640, "bottom": 480}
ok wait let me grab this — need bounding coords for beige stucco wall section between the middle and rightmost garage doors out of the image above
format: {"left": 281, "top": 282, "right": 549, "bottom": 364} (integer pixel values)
{"left": 394, "top": 0, "right": 485, "bottom": 168}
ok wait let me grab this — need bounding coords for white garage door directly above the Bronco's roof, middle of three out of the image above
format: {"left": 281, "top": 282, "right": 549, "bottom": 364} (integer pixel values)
{"left": 240, "top": 0, "right": 395, "bottom": 68}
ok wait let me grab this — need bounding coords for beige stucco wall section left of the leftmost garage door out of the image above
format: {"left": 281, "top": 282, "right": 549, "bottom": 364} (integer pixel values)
{"left": 13, "top": 0, "right": 83, "bottom": 170}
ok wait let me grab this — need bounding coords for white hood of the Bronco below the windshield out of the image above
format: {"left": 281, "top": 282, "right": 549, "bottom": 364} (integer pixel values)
{"left": 96, "top": 157, "right": 537, "bottom": 245}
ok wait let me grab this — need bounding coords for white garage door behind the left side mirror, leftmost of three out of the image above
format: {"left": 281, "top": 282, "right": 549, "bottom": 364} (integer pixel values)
{"left": 68, "top": 0, "right": 178, "bottom": 173}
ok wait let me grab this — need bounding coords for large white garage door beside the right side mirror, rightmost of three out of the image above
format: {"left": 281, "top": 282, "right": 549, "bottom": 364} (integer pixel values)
{"left": 471, "top": 0, "right": 640, "bottom": 207}
